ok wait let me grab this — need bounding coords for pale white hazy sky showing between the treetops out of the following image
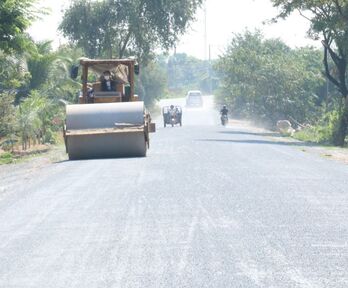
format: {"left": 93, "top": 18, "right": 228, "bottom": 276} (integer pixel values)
{"left": 29, "top": 0, "right": 319, "bottom": 59}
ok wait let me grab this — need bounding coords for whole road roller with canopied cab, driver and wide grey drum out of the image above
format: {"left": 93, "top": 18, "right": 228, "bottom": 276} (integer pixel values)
{"left": 63, "top": 59, "right": 156, "bottom": 160}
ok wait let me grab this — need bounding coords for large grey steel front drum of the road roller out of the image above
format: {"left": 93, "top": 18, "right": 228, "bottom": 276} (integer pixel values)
{"left": 66, "top": 102, "right": 147, "bottom": 160}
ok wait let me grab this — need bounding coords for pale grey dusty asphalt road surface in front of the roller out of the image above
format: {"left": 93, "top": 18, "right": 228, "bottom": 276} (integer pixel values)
{"left": 0, "top": 98, "right": 348, "bottom": 288}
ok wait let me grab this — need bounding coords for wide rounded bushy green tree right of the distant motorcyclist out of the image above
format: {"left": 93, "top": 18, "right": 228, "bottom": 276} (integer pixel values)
{"left": 216, "top": 31, "right": 323, "bottom": 125}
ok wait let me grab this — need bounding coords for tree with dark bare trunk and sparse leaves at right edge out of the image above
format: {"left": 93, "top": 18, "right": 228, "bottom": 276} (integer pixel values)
{"left": 272, "top": 0, "right": 348, "bottom": 146}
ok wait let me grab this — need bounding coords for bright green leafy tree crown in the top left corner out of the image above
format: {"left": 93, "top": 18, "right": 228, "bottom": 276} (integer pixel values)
{"left": 0, "top": 0, "right": 37, "bottom": 53}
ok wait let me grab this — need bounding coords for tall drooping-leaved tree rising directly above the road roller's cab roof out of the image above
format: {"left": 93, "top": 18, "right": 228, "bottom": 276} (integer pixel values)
{"left": 60, "top": 0, "right": 202, "bottom": 62}
